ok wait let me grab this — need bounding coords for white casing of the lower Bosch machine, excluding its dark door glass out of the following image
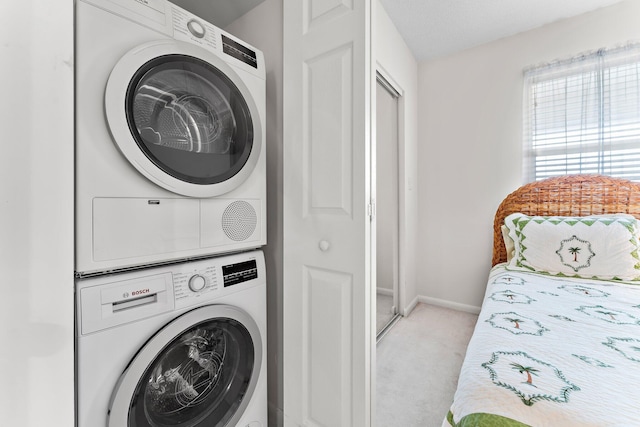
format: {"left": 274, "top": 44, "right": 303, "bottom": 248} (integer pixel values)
{"left": 76, "top": 251, "right": 267, "bottom": 427}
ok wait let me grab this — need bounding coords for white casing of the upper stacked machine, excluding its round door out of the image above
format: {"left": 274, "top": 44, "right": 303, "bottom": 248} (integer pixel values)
{"left": 75, "top": 0, "right": 266, "bottom": 277}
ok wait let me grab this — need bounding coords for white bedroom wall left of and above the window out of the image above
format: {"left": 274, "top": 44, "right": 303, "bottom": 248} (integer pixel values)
{"left": 417, "top": 0, "right": 640, "bottom": 311}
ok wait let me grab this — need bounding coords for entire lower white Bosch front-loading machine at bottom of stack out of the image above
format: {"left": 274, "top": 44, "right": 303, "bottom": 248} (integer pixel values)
{"left": 76, "top": 250, "right": 267, "bottom": 427}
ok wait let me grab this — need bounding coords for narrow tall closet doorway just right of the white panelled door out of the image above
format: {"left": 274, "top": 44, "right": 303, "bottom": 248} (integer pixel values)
{"left": 375, "top": 72, "right": 400, "bottom": 341}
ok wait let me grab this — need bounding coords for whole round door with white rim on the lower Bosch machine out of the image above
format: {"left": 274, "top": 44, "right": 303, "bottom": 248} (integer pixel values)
{"left": 108, "top": 305, "right": 263, "bottom": 427}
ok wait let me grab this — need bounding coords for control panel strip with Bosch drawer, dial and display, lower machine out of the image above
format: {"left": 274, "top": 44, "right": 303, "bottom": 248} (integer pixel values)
{"left": 76, "top": 250, "right": 266, "bottom": 335}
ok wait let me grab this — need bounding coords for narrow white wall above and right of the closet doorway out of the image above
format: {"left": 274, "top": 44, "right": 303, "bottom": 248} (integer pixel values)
{"left": 373, "top": 1, "right": 418, "bottom": 314}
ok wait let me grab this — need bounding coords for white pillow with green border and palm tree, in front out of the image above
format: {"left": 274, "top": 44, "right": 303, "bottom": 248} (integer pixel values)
{"left": 505, "top": 213, "right": 640, "bottom": 282}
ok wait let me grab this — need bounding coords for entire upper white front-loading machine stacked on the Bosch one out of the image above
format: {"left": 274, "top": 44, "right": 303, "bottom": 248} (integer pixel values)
{"left": 75, "top": 0, "right": 266, "bottom": 277}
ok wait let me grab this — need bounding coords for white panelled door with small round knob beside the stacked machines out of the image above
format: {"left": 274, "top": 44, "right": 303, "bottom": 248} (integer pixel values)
{"left": 283, "top": 0, "right": 375, "bottom": 427}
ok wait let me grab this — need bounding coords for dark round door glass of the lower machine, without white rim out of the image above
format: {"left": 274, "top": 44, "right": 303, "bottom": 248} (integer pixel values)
{"left": 128, "top": 318, "right": 259, "bottom": 427}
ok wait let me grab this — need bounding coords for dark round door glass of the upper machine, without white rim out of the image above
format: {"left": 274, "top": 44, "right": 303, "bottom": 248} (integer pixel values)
{"left": 126, "top": 54, "right": 254, "bottom": 185}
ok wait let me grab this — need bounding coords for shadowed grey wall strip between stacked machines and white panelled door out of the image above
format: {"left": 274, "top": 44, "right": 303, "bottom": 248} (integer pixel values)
{"left": 225, "top": 0, "right": 283, "bottom": 426}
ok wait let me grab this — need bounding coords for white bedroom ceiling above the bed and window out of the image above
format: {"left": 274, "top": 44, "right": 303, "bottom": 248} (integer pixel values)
{"left": 380, "top": 0, "right": 624, "bottom": 61}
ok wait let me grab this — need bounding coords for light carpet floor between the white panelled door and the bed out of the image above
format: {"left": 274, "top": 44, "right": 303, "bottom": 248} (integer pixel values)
{"left": 376, "top": 304, "right": 478, "bottom": 427}
